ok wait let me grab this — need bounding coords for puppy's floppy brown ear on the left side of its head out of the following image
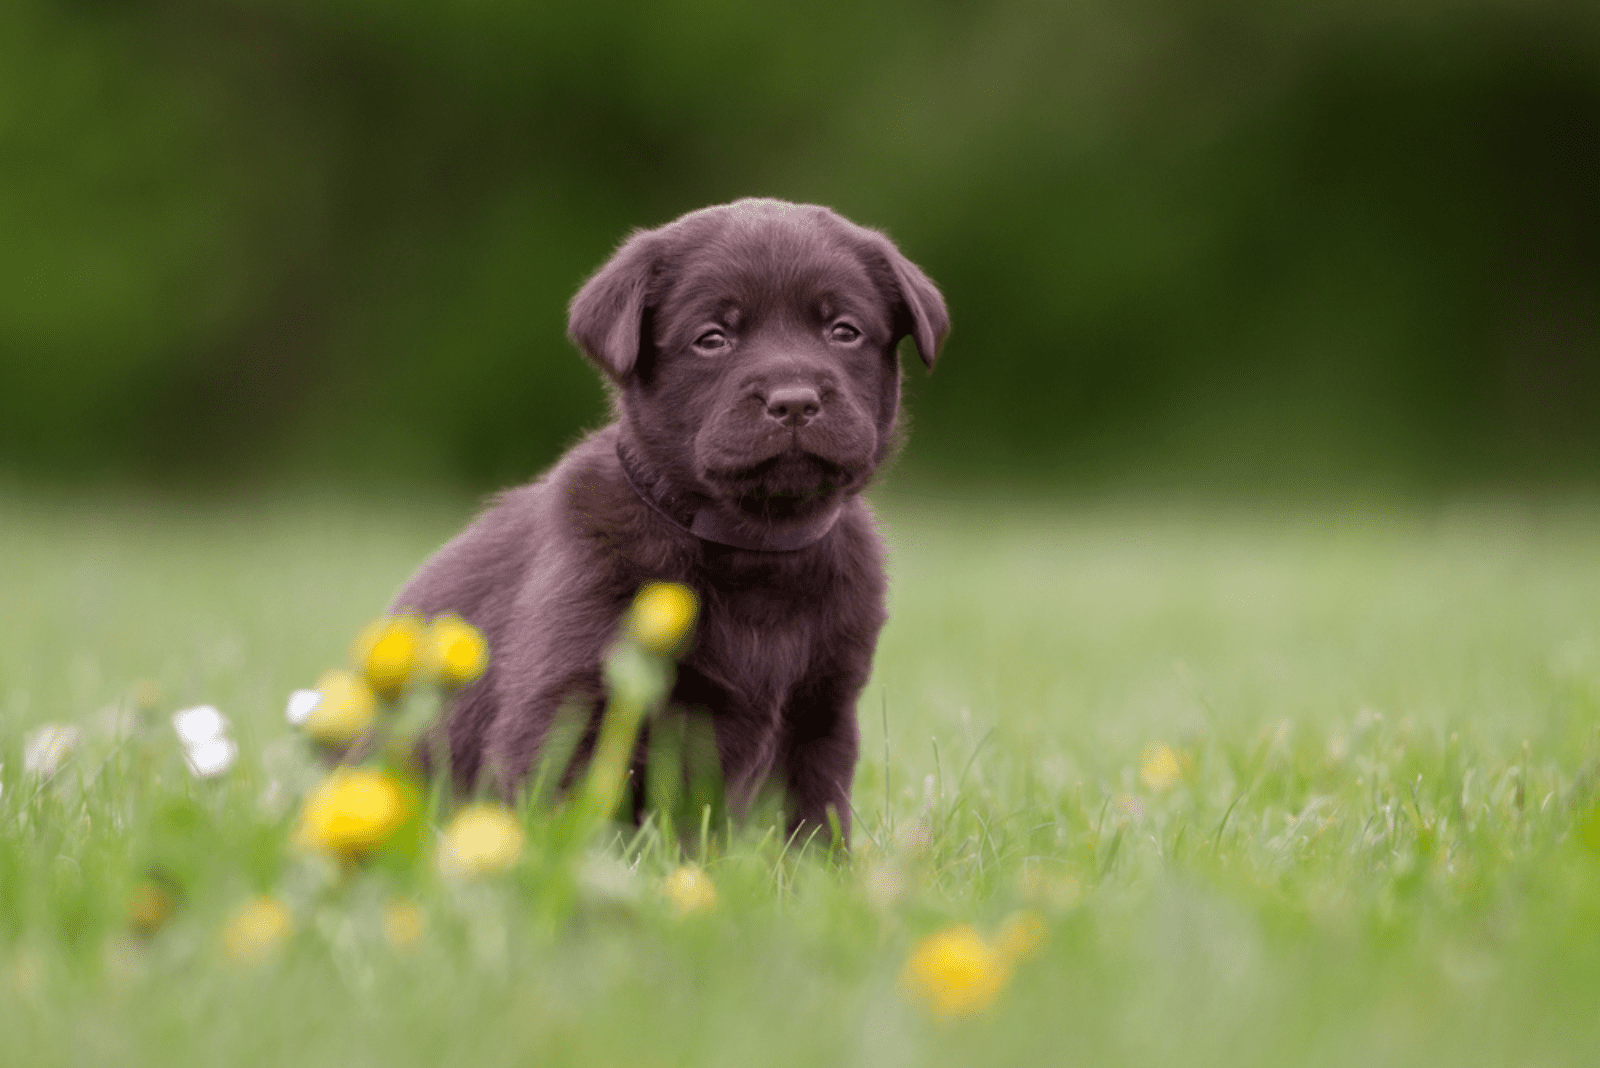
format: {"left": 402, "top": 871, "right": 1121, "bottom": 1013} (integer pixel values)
{"left": 566, "top": 230, "right": 662, "bottom": 382}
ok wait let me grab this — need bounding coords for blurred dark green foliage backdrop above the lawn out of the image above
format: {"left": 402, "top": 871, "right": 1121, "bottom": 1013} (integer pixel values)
{"left": 0, "top": 0, "right": 1600, "bottom": 489}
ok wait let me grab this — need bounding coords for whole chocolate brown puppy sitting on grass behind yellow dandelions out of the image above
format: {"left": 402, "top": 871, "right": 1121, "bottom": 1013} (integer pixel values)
{"left": 394, "top": 200, "right": 949, "bottom": 838}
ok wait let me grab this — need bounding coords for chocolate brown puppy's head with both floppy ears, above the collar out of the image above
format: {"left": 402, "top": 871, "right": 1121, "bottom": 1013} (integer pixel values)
{"left": 568, "top": 200, "right": 949, "bottom": 523}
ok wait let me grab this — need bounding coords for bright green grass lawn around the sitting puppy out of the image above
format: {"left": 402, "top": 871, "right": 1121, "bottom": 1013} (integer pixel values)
{"left": 0, "top": 497, "right": 1600, "bottom": 1068}
